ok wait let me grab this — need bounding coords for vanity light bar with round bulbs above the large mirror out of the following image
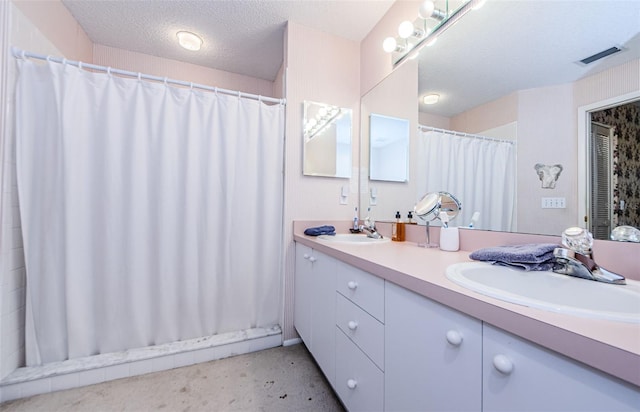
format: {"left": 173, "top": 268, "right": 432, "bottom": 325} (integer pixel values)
{"left": 382, "top": 0, "right": 486, "bottom": 67}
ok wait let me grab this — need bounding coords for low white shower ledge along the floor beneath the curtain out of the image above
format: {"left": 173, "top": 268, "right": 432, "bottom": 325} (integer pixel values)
{"left": 0, "top": 326, "right": 282, "bottom": 402}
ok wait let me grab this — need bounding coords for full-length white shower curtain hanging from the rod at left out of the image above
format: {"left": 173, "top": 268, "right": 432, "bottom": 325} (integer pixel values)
{"left": 16, "top": 59, "right": 284, "bottom": 365}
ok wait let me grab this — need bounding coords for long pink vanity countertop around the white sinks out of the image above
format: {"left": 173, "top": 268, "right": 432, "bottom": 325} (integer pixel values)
{"left": 294, "top": 222, "right": 640, "bottom": 386}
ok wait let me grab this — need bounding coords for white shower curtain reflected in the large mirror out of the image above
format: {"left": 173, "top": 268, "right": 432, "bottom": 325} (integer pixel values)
{"left": 418, "top": 129, "right": 516, "bottom": 231}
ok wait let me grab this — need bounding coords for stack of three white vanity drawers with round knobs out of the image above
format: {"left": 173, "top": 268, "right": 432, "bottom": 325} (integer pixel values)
{"left": 334, "top": 264, "right": 385, "bottom": 411}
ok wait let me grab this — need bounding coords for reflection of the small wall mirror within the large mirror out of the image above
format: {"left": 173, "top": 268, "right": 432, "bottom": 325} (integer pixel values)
{"left": 369, "top": 113, "right": 409, "bottom": 182}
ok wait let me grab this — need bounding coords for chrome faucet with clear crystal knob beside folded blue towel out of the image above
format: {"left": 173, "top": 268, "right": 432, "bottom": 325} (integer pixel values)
{"left": 553, "top": 227, "right": 627, "bottom": 285}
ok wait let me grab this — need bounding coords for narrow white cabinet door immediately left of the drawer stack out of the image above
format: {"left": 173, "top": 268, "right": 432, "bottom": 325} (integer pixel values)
{"left": 310, "top": 251, "right": 338, "bottom": 385}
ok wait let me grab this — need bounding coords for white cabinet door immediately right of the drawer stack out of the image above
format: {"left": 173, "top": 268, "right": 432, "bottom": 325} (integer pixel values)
{"left": 385, "top": 282, "right": 482, "bottom": 411}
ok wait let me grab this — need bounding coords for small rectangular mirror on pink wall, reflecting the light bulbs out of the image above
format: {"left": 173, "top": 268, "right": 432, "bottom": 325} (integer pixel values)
{"left": 302, "top": 101, "right": 351, "bottom": 178}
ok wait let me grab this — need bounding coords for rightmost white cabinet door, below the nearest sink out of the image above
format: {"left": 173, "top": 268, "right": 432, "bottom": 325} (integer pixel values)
{"left": 482, "top": 324, "right": 640, "bottom": 412}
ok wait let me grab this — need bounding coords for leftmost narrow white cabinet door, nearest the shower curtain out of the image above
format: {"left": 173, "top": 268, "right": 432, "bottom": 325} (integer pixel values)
{"left": 293, "top": 243, "right": 315, "bottom": 348}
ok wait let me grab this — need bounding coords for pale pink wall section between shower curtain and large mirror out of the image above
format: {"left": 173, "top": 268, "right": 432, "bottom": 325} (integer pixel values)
{"left": 283, "top": 22, "right": 360, "bottom": 340}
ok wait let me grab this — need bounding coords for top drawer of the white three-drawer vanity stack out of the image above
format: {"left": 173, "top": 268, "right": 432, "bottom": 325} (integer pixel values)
{"left": 336, "top": 263, "right": 384, "bottom": 323}
